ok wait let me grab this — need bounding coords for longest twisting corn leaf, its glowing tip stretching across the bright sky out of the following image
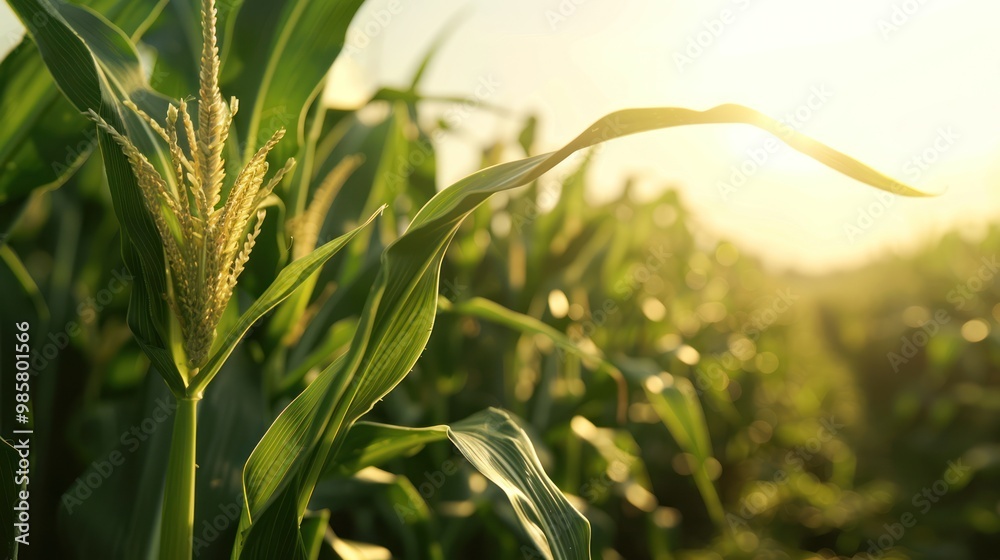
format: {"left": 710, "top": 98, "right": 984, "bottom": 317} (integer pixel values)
{"left": 233, "top": 105, "right": 923, "bottom": 558}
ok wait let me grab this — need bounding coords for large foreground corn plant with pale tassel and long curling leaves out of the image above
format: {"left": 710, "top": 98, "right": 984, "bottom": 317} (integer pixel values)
{"left": 0, "top": 0, "right": 922, "bottom": 559}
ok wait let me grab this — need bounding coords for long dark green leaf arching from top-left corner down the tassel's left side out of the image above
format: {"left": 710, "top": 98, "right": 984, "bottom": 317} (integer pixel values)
{"left": 8, "top": 0, "right": 184, "bottom": 395}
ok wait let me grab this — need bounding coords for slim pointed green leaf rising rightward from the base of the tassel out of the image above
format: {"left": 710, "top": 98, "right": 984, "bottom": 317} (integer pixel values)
{"left": 189, "top": 209, "right": 382, "bottom": 394}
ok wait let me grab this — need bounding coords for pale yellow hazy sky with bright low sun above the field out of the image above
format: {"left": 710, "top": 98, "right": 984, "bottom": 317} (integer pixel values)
{"left": 0, "top": 0, "right": 1000, "bottom": 273}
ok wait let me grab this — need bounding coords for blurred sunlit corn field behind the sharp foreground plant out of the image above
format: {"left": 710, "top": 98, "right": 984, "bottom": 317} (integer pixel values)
{"left": 0, "top": 1, "right": 1000, "bottom": 560}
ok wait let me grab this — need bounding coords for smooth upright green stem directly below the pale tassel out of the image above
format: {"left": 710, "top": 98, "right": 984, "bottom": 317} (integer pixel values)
{"left": 160, "top": 397, "right": 200, "bottom": 560}
